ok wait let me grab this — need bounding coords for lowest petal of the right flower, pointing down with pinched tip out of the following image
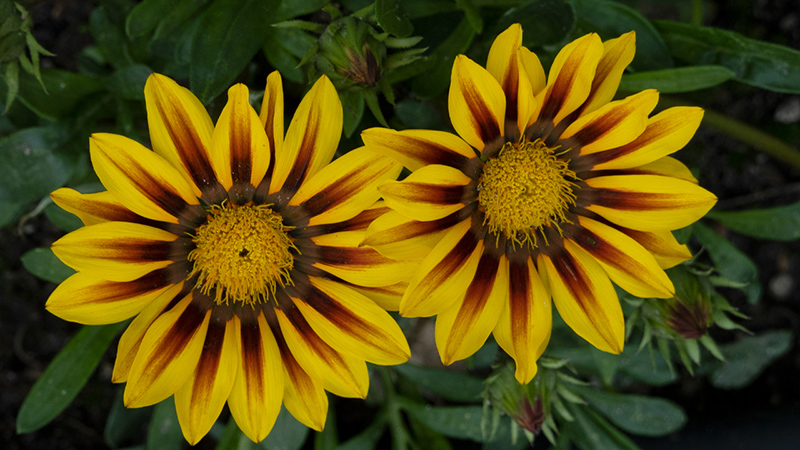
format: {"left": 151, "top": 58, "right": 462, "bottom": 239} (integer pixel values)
{"left": 494, "top": 258, "right": 553, "bottom": 384}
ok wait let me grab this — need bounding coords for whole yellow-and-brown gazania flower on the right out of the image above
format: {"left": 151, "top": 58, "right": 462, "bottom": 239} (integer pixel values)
{"left": 363, "top": 25, "right": 716, "bottom": 383}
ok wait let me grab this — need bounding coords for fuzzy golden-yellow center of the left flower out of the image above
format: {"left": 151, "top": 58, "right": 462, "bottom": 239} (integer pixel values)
{"left": 188, "top": 205, "right": 295, "bottom": 305}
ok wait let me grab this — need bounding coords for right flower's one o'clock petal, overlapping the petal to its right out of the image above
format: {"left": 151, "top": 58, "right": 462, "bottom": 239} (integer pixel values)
{"left": 539, "top": 33, "right": 603, "bottom": 125}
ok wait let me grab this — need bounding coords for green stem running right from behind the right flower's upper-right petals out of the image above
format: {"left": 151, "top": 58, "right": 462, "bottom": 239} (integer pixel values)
{"left": 659, "top": 97, "right": 800, "bottom": 168}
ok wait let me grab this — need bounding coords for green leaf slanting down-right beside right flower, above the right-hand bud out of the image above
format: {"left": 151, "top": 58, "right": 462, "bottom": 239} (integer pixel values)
{"left": 693, "top": 223, "right": 761, "bottom": 304}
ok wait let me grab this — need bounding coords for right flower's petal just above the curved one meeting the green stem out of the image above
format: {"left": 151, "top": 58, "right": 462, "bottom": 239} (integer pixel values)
{"left": 561, "top": 89, "right": 658, "bottom": 155}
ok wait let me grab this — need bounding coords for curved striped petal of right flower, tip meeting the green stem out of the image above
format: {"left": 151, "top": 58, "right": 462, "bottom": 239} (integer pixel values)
{"left": 593, "top": 106, "right": 703, "bottom": 170}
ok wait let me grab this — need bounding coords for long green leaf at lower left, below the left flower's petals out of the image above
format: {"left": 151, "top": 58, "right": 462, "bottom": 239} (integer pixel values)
{"left": 17, "top": 322, "right": 125, "bottom": 433}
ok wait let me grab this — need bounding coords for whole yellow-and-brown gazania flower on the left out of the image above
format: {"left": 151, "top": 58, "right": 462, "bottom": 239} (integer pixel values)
{"left": 47, "top": 72, "right": 413, "bottom": 444}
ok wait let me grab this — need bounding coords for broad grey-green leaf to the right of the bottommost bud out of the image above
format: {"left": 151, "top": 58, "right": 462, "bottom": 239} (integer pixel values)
{"left": 574, "top": 388, "right": 686, "bottom": 436}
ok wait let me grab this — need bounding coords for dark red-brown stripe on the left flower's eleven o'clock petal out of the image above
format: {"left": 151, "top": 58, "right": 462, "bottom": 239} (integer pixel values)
{"left": 154, "top": 90, "right": 219, "bottom": 197}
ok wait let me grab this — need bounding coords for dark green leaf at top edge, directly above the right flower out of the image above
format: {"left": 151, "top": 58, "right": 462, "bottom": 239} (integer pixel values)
{"left": 491, "top": 0, "right": 575, "bottom": 48}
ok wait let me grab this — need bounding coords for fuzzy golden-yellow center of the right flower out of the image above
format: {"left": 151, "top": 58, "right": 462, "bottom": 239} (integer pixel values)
{"left": 478, "top": 139, "right": 577, "bottom": 247}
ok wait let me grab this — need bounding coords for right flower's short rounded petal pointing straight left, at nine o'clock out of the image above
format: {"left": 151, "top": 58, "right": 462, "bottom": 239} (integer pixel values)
{"left": 378, "top": 165, "right": 475, "bottom": 221}
